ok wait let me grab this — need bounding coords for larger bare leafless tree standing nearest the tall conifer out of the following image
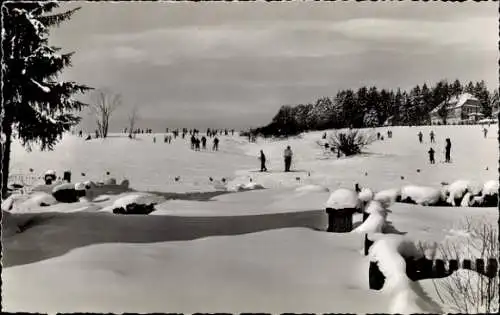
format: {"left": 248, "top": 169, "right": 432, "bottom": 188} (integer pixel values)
{"left": 90, "top": 89, "right": 122, "bottom": 138}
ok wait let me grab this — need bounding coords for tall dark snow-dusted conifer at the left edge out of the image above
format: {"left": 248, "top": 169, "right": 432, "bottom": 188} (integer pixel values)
{"left": 0, "top": 1, "right": 90, "bottom": 198}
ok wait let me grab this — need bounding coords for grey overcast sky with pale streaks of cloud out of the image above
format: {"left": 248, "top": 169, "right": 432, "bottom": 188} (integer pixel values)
{"left": 51, "top": 1, "right": 498, "bottom": 132}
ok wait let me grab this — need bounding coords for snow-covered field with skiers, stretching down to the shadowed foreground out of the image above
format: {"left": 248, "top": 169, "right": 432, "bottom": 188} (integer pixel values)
{"left": 2, "top": 126, "right": 499, "bottom": 313}
